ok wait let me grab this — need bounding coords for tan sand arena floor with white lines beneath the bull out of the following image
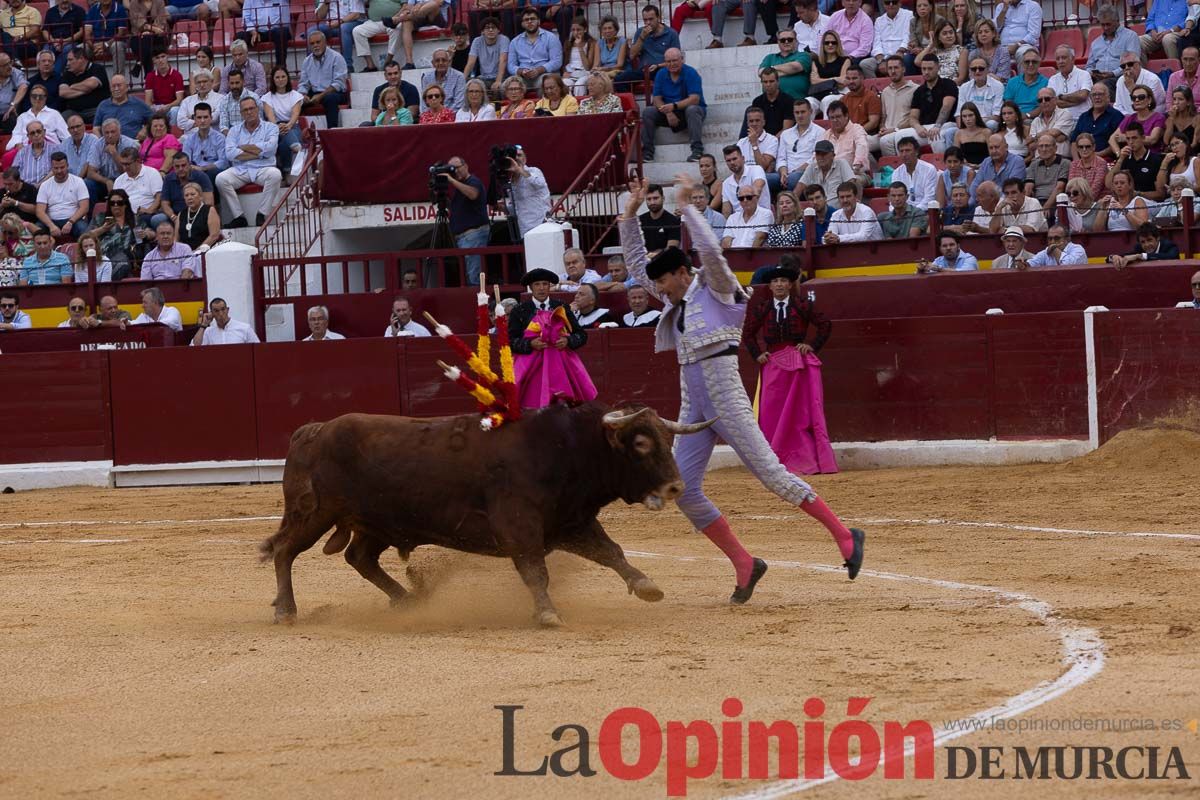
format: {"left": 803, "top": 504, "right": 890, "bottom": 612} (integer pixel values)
{"left": 0, "top": 431, "right": 1200, "bottom": 798}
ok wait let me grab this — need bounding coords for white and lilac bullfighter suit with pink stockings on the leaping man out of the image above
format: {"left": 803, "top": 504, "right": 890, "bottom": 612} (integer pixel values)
{"left": 618, "top": 204, "right": 865, "bottom": 604}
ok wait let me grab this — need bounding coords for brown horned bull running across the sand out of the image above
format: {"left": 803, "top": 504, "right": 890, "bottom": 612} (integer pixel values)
{"left": 259, "top": 403, "right": 715, "bottom": 626}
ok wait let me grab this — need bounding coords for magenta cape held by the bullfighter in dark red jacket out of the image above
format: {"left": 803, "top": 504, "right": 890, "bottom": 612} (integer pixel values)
{"left": 758, "top": 347, "right": 838, "bottom": 475}
